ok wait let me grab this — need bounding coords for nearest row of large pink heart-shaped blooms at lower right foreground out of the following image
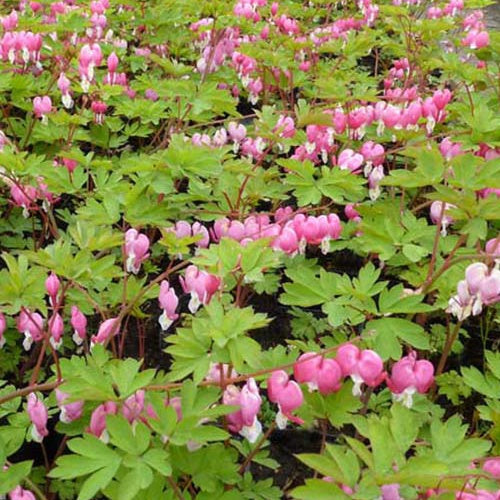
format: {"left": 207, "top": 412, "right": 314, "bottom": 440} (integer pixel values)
{"left": 215, "top": 343, "right": 434, "bottom": 442}
